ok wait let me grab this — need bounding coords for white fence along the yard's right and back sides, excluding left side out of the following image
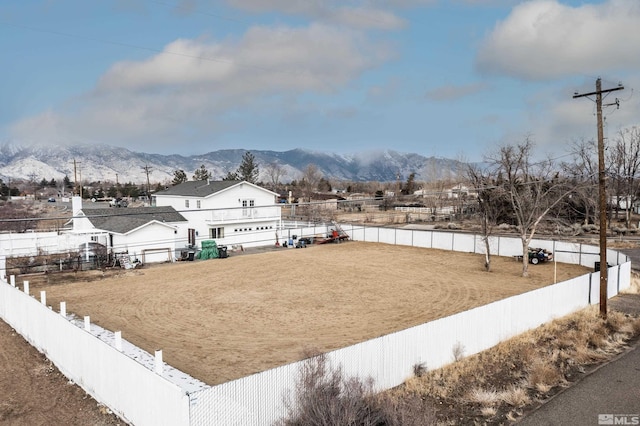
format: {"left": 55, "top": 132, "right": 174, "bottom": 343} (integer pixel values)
{"left": 191, "top": 225, "right": 631, "bottom": 425}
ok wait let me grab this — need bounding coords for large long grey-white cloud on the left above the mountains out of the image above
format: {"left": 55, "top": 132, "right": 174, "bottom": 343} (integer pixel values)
{"left": 11, "top": 25, "right": 392, "bottom": 152}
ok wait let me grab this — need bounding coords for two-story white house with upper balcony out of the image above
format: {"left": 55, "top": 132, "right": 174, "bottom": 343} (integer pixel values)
{"left": 151, "top": 180, "right": 281, "bottom": 247}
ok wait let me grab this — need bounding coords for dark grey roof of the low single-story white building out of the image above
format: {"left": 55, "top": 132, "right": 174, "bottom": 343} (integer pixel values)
{"left": 83, "top": 207, "right": 187, "bottom": 234}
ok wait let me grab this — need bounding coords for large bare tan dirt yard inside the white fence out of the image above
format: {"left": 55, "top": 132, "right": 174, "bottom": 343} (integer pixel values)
{"left": 19, "top": 242, "right": 588, "bottom": 385}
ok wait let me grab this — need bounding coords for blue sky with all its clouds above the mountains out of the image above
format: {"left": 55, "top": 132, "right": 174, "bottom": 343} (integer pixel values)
{"left": 0, "top": 0, "right": 640, "bottom": 161}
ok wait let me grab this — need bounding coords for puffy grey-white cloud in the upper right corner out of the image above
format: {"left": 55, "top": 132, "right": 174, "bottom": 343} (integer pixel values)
{"left": 476, "top": 0, "right": 640, "bottom": 80}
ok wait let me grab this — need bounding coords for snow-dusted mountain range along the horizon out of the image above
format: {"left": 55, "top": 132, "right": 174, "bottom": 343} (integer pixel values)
{"left": 0, "top": 143, "right": 462, "bottom": 183}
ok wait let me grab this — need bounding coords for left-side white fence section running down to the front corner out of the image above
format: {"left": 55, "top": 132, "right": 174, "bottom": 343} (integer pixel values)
{"left": 0, "top": 283, "right": 189, "bottom": 425}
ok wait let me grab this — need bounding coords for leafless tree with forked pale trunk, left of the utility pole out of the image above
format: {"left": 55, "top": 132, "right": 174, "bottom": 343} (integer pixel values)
{"left": 489, "top": 137, "right": 573, "bottom": 277}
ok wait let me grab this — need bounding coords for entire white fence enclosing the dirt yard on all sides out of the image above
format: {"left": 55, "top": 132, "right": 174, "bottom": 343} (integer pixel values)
{"left": 0, "top": 225, "right": 631, "bottom": 426}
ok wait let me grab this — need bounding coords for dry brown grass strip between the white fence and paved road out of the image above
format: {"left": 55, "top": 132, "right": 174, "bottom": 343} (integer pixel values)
{"left": 392, "top": 307, "right": 640, "bottom": 424}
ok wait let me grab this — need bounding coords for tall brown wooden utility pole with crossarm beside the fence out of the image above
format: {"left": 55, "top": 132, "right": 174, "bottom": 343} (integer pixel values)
{"left": 573, "top": 78, "right": 624, "bottom": 319}
